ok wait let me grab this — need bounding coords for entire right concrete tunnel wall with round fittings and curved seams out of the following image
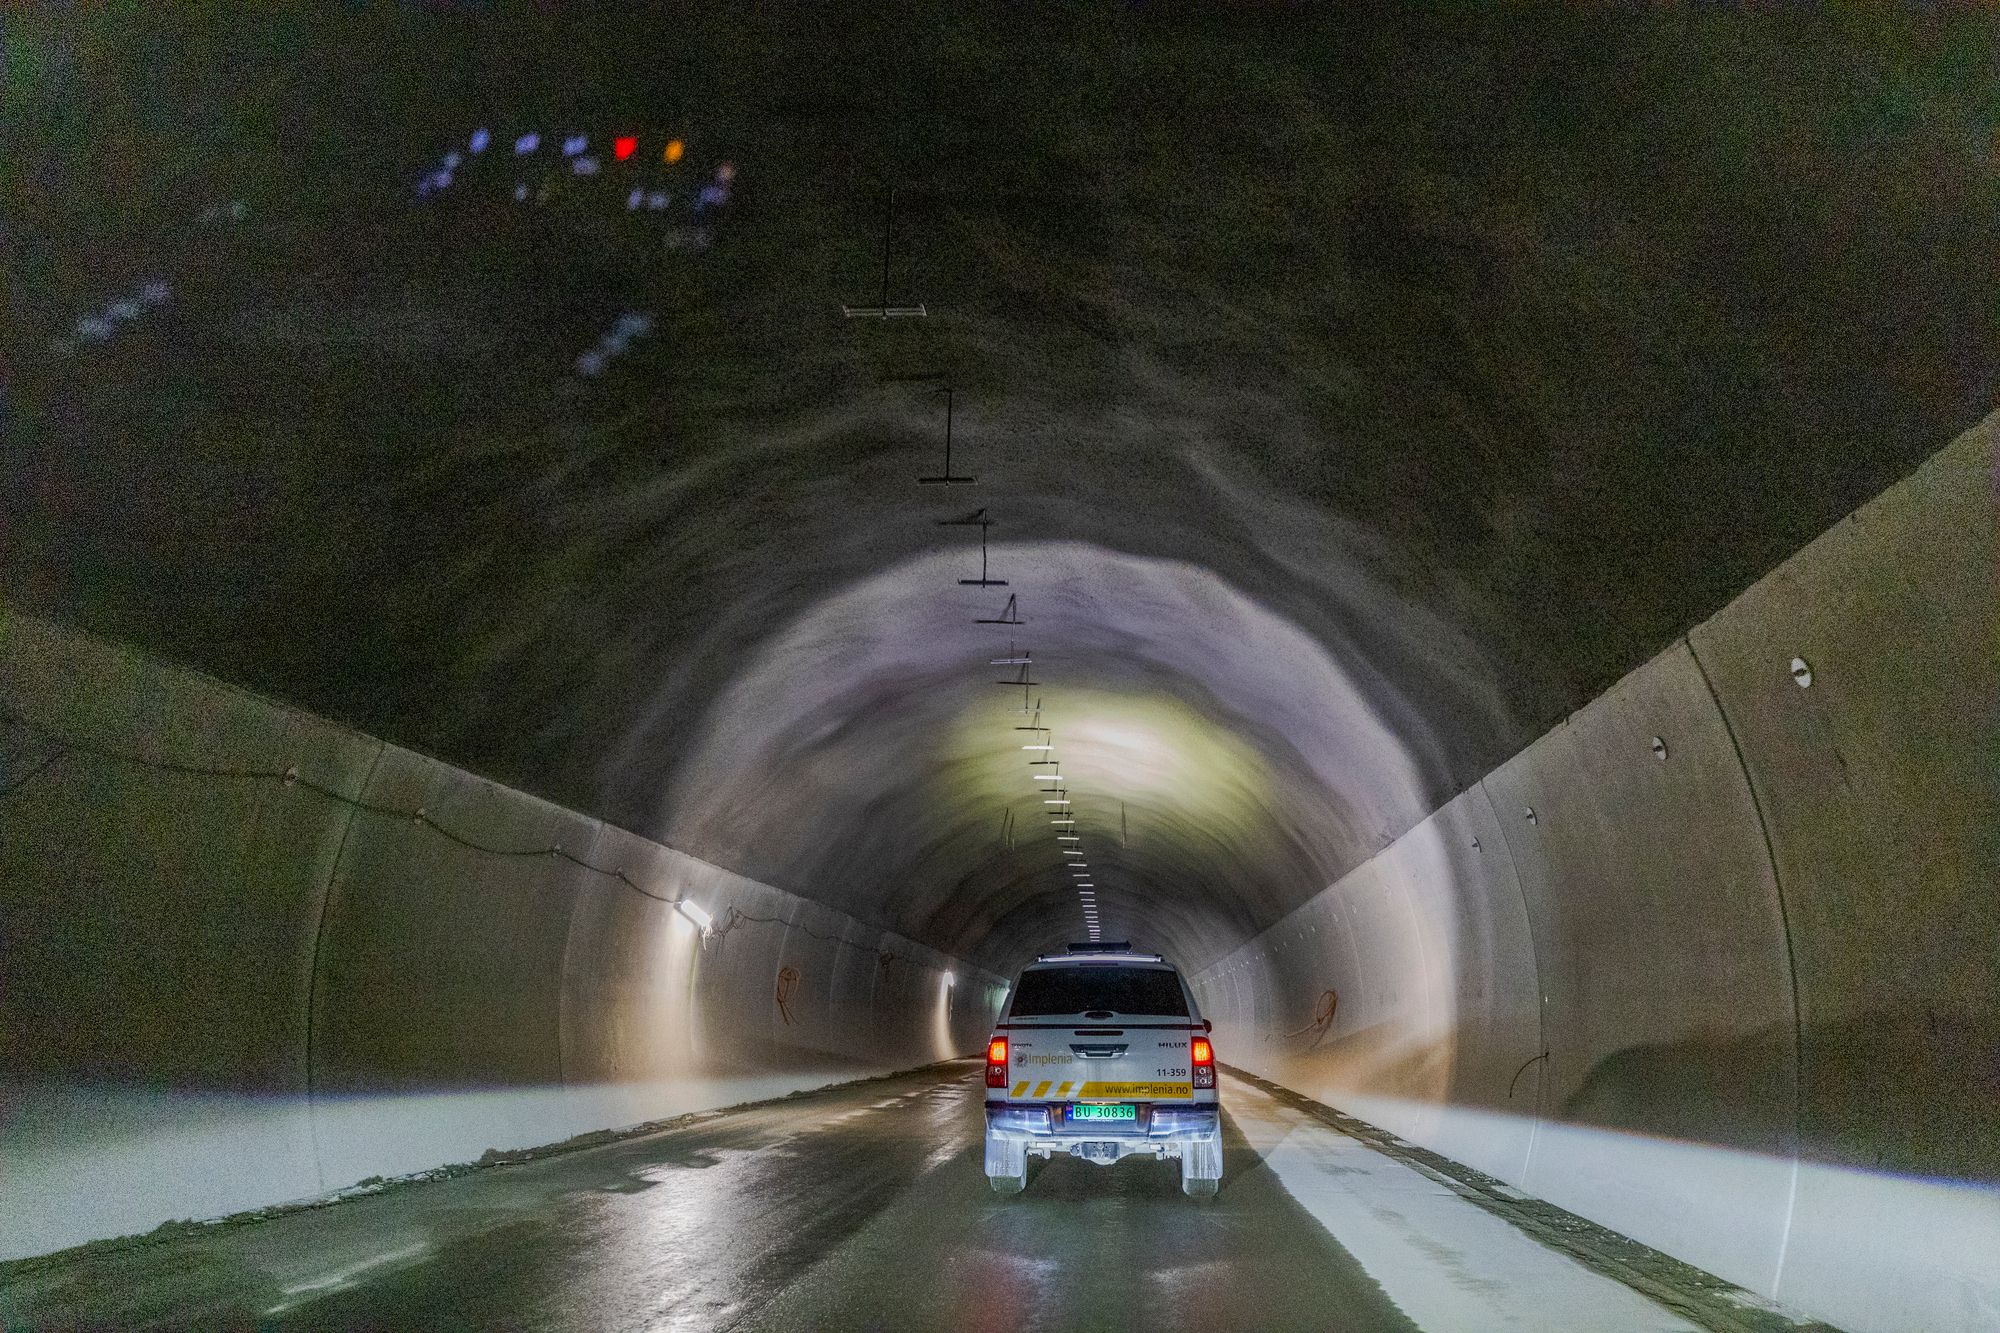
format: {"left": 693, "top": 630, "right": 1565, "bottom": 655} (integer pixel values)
{"left": 1196, "top": 416, "right": 2000, "bottom": 1329}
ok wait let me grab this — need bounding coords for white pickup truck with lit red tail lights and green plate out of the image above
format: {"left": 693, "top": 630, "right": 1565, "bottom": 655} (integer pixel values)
{"left": 986, "top": 945, "right": 1222, "bottom": 1199}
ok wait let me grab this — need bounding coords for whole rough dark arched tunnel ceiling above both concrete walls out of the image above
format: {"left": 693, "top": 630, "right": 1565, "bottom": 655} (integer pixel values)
{"left": 15, "top": 6, "right": 2000, "bottom": 967}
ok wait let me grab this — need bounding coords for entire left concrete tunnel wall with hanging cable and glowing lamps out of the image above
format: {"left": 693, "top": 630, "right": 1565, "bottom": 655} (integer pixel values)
{"left": 0, "top": 614, "right": 1002, "bottom": 1259}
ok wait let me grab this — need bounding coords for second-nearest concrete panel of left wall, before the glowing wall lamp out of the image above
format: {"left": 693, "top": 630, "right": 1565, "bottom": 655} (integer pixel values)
{"left": 312, "top": 747, "right": 598, "bottom": 1185}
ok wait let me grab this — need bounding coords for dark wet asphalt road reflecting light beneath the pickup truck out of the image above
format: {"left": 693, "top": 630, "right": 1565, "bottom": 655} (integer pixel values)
{"left": 0, "top": 1063, "right": 1414, "bottom": 1331}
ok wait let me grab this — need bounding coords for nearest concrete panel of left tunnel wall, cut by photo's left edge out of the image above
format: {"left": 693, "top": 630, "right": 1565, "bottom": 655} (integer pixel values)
{"left": 0, "top": 614, "right": 380, "bottom": 1257}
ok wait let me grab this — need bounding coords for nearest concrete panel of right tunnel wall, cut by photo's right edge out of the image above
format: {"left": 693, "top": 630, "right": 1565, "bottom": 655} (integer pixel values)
{"left": 1690, "top": 412, "right": 2000, "bottom": 1327}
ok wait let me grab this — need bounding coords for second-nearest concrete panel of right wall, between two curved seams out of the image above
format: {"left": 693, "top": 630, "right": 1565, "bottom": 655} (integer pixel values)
{"left": 1484, "top": 646, "right": 1794, "bottom": 1289}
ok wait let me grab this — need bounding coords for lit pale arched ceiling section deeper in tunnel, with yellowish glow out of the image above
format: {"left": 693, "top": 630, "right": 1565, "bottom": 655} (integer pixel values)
{"left": 662, "top": 536, "right": 1472, "bottom": 971}
